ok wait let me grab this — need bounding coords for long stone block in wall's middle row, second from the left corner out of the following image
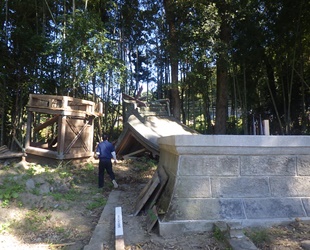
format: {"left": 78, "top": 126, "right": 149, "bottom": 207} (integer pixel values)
{"left": 211, "top": 177, "right": 270, "bottom": 198}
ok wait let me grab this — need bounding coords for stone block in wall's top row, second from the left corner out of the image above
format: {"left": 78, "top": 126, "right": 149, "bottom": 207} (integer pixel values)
{"left": 240, "top": 155, "right": 296, "bottom": 176}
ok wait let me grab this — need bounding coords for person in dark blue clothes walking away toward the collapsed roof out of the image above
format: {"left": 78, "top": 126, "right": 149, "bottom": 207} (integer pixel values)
{"left": 95, "top": 134, "right": 118, "bottom": 188}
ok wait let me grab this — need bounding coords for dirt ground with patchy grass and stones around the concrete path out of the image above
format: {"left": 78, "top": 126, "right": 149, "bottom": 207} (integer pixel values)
{"left": 0, "top": 158, "right": 310, "bottom": 250}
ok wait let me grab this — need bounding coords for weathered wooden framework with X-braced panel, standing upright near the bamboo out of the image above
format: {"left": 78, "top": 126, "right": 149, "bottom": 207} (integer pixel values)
{"left": 25, "top": 94, "right": 102, "bottom": 160}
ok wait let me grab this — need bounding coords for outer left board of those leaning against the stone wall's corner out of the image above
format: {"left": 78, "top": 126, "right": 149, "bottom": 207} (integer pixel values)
{"left": 134, "top": 171, "right": 160, "bottom": 216}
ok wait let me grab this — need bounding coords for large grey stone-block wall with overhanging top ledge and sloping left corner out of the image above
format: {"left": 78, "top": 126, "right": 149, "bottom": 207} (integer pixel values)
{"left": 157, "top": 135, "right": 310, "bottom": 235}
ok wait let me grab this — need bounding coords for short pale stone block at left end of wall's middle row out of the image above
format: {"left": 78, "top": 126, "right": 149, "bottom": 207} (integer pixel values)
{"left": 174, "top": 176, "right": 211, "bottom": 198}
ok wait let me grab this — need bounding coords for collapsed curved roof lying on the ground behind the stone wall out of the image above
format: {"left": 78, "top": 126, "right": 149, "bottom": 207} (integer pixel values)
{"left": 116, "top": 93, "right": 198, "bottom": 159}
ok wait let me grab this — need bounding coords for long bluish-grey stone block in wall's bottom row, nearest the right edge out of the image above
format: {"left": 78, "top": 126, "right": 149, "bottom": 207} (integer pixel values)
{"left": 243, "top": 198, "right": 305, "bottom": 219}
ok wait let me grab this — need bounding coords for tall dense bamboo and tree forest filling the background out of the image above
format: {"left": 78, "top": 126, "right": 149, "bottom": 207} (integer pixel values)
{"left": 0, "top": 0, "right": 310, "bottom": 148}
